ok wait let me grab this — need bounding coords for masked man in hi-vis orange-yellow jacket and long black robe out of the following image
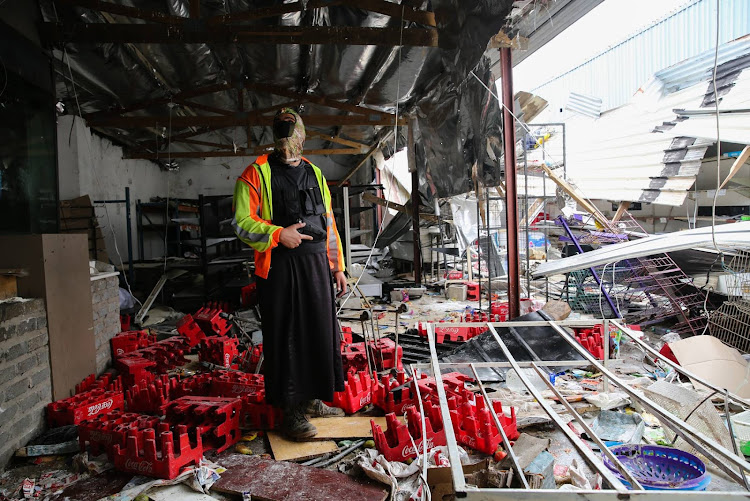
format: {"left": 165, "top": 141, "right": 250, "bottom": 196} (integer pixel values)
{"left": 232, "top": 108, "right": 346, "bottom": 440}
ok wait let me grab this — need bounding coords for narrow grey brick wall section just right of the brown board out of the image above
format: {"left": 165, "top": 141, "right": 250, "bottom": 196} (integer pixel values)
{"left": 91, "top": 276, "right": 120, "bottom": 374}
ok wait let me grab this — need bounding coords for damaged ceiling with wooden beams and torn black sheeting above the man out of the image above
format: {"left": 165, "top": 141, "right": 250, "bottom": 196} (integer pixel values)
{"left": 40, "top": 0, "right": 548, "bottom": 198}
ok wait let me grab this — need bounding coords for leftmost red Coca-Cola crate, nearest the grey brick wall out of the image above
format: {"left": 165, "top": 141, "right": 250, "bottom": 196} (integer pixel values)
{"left": 47, "top": 390, "right": 125, "bottom": 428}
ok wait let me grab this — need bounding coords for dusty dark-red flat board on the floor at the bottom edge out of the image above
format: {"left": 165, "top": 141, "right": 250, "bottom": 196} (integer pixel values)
{"left": 211, "top": 454, "right": 389, "bottom": 501}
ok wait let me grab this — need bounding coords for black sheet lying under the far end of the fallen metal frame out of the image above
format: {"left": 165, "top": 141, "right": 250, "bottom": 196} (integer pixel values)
{"left": 440, "top": 311, "right": 587, "bottom": 382}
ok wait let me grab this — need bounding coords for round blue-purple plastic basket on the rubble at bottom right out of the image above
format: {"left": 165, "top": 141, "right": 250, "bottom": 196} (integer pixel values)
{"left": 604, "top": 444, "right": 711, "bottom": 491}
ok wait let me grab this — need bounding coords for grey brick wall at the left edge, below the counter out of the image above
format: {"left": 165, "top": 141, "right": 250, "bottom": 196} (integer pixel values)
{"left": 0, "top": 299, "right": 52, "bottom": 469}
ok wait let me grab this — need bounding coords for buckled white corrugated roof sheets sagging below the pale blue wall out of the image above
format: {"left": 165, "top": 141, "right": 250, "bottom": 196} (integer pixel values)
{"left": 528, "top": 39, "right": 750, "bottom": 206}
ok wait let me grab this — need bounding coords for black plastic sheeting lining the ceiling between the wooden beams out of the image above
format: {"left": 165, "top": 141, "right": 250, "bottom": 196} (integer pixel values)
{"left": 40, "top": 0, "right": 512, "bottom": 195}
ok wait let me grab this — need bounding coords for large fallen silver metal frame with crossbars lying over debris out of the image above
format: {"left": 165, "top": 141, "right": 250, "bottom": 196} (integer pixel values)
{"left": 420, "top": 319, "right": 750, "bottom": 501}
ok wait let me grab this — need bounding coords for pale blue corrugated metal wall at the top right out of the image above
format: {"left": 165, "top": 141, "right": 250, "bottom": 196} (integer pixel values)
{"left": 531, "top": 0, "right": 750, "bottom": 112}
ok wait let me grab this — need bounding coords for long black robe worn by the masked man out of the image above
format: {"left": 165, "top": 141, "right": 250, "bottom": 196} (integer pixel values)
{"left": 256, "top": 157, "right": 344, "bottom": 407}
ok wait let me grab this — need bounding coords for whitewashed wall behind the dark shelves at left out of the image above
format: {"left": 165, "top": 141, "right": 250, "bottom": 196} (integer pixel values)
{"left": 57, "top": 115, "right": 167, "bottom": 265}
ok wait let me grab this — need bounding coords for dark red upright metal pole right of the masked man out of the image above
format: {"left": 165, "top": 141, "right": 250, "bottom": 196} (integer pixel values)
{"left": 500, "top": 48, "right": 521, "bottom": 319}
